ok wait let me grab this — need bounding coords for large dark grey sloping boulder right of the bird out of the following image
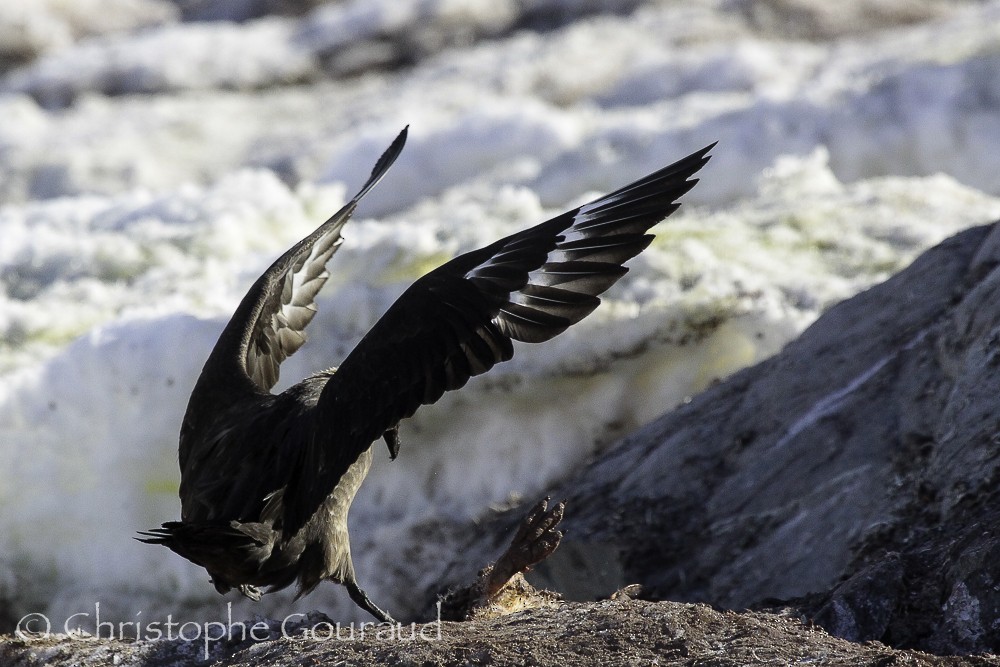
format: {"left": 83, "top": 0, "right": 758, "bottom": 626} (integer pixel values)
{"left": 543, "top": 224, "right": 1000, "bottom": 654}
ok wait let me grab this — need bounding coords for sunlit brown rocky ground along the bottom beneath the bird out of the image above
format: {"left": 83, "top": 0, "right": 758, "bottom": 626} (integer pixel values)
{"left": 7, "top": 598, "right": 1000, "bottom": 667}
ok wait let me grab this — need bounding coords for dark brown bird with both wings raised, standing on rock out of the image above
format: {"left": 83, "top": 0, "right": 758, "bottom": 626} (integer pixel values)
{"left": 142, "top": 129, "right": 715, "bottom": 621}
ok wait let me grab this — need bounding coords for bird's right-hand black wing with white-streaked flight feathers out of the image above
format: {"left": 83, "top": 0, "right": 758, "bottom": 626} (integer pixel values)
{"left": 284, "top": 144, "right": 715, "bottom": 531}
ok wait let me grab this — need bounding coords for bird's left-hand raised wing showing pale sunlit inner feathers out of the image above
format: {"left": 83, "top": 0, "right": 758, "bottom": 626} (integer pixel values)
{"left": 195, "top": 128, "right": 407, "bottom": 392}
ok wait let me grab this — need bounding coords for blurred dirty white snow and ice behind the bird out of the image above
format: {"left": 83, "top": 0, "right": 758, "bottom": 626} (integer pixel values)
{"left": 0, "top": 0, "right": 1000, "bottom": 619}
